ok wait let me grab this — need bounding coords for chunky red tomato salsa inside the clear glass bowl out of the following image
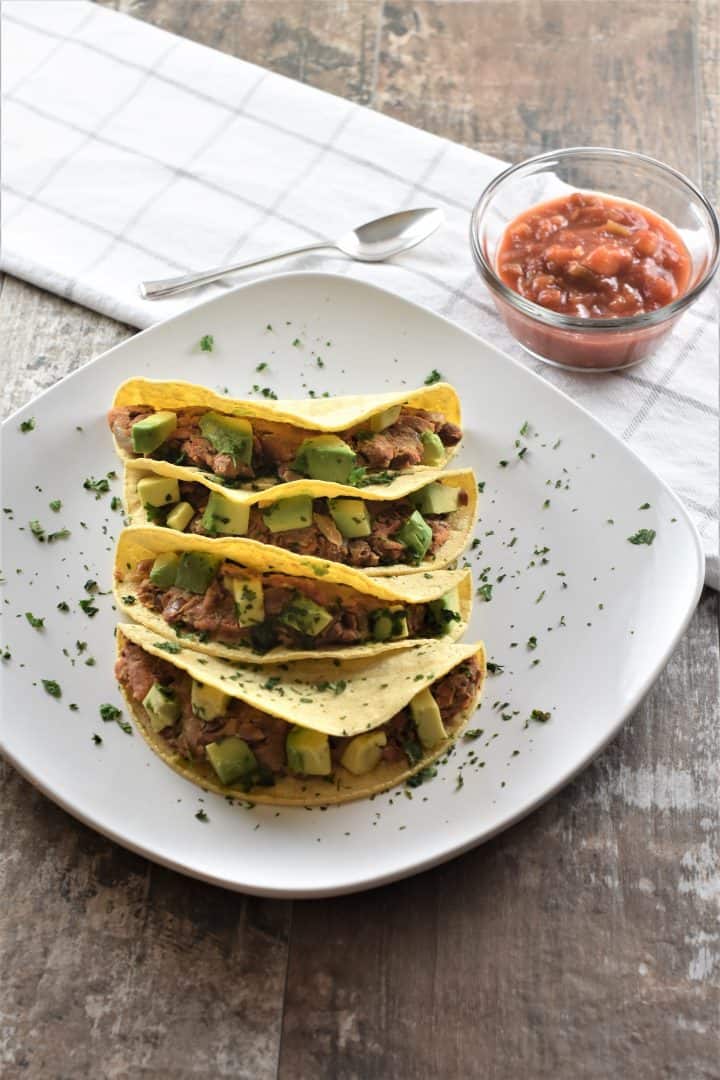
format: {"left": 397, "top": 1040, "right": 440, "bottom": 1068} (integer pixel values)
{"left": 497, "top": 192, "right": 691, "bottom": 319}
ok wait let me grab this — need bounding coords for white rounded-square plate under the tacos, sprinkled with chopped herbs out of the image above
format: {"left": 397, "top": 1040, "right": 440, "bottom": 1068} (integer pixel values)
{"left": 1, "top": 273, "right": 703, "bottom": 896}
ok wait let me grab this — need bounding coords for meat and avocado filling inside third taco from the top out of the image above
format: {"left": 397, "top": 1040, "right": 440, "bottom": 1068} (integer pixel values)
{"left": 121, "top": 551, "right": 462, "bottom": 653}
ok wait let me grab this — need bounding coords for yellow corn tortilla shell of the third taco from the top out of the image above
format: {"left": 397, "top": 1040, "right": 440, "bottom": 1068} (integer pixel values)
{"left": 114, "top": 525, "right": 473, "bottom": 665}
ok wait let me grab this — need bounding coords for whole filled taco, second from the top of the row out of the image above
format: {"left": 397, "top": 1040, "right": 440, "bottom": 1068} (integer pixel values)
{"left": 125, "top": 458, "right": 477, "bottom": 577}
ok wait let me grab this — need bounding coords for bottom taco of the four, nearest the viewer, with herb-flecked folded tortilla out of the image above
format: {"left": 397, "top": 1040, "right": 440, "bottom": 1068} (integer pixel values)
{"left": 116, "top": 625, "right": 486, "bottom": 806}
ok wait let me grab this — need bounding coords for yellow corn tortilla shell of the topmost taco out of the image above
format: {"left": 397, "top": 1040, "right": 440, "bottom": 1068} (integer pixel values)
{"left": 112, "top": 378, "right": 461, "bottom": 432}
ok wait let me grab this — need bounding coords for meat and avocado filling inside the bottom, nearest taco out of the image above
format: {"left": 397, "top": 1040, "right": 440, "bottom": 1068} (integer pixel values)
{"left": 116, "top": 640, "right": 481, "bottom": 791}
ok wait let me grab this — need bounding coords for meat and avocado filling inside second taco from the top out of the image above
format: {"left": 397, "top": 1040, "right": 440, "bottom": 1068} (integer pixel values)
{"left": 137, "top": 476, "right": 467, "bottom": 568}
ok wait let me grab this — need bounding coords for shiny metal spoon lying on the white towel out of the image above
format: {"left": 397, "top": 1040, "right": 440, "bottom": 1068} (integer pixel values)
{"left": 140, "top": 207, "right": 445, "bottom": 300}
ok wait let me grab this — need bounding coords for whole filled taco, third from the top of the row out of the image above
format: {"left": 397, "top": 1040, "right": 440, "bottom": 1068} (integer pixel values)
{"left": 114, "top": 526, "right": 472, "bottom": 663}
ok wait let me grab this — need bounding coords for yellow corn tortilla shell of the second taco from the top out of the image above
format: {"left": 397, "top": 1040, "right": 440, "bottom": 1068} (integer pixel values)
{"left": 124, "top": 458, "right": 477, "bottom": 578}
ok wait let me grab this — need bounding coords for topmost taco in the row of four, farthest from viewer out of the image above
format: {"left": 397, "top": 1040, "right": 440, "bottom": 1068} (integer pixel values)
{"left": 108, "top": 378, "right": 462, "bottom": 487}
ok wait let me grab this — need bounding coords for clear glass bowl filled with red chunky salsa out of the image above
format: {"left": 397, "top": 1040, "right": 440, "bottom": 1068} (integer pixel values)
{"left": 471, "top": 147, "right": 720, "bottom": 372}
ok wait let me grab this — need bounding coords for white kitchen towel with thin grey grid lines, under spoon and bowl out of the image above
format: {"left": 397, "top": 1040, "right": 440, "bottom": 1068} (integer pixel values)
{"left": 1, "top": 0, "right": 720, "bottom": 589}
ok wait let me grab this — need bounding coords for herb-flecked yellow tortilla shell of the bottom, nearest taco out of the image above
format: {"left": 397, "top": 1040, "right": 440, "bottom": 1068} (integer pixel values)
{"left": 117, "top": 624, "right": 486, "bottom": 806}
